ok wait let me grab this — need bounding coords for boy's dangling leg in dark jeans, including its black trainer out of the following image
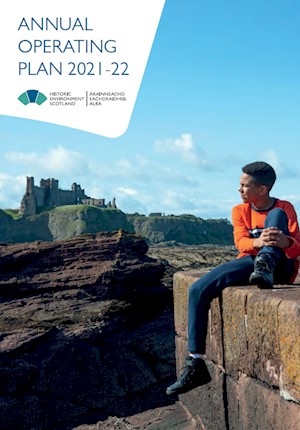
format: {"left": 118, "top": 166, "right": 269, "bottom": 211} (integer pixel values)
{"left": 166, "top": 256, "right": 253, "bottom": 394}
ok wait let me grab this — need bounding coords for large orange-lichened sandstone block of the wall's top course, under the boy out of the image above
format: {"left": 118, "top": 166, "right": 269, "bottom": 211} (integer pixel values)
{"left": 223, "top": 286, "right": 300, "bottom": 401}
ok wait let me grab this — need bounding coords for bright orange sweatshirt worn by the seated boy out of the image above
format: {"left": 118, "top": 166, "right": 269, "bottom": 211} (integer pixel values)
{"left": 232, "top": 199, "right": 300, "bottom": 258}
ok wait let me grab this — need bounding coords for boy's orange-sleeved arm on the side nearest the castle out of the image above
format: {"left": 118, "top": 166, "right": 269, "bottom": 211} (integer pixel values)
{"left": 232, "top": 206, "right": 257, "bottom": 255}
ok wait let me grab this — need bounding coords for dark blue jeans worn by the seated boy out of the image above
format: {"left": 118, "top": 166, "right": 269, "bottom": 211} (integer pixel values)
{"left": 188, "top": 208, "right": 294, "bottom": 354}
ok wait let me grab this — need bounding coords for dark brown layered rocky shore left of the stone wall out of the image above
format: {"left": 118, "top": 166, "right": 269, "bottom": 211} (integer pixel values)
{"left": 0, "top": 235, "right": 234, "bottom": 430}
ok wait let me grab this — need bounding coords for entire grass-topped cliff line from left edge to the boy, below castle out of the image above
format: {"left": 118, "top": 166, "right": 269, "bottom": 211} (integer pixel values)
{"left": 0, "top": 205, "right": 233, "bottom": 245}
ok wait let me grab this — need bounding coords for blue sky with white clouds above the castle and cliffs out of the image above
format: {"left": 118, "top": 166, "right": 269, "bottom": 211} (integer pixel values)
{"left": 0, "top": 0, "right": 300, "bottom": 220}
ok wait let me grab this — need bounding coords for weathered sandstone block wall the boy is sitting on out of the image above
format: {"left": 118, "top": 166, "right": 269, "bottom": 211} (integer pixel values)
{"left": 174, "top": 271, "right": 300, "bottom": 430}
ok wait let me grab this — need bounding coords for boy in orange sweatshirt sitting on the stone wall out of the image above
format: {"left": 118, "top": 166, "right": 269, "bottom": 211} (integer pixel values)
{"left": 166, "top": 161, "right": 300, "bottom": 394}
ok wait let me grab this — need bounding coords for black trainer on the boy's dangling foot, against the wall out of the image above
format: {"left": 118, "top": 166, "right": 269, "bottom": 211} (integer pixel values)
{"left": 166, "top": 356, "right": 211, "bottom": 394}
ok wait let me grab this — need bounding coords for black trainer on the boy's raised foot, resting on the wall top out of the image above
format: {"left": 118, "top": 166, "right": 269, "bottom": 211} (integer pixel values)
{"left": 249, "top": 252, "right": 275, "bottom": 288}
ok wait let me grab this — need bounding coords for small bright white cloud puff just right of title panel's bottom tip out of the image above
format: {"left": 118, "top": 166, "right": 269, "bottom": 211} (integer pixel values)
{"left": 154, "top": 133, "right": 206, "bottom": 166}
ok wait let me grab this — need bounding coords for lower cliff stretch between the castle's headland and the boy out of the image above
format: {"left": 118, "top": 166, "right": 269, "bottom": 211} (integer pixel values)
{"left": 127, "top": 215, "right": 233, "bottom": 245}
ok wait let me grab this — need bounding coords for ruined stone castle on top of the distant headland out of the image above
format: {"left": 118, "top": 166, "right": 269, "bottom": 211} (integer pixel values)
{"left": 19, "top": 176, "right": 117, "bottom": 215}
